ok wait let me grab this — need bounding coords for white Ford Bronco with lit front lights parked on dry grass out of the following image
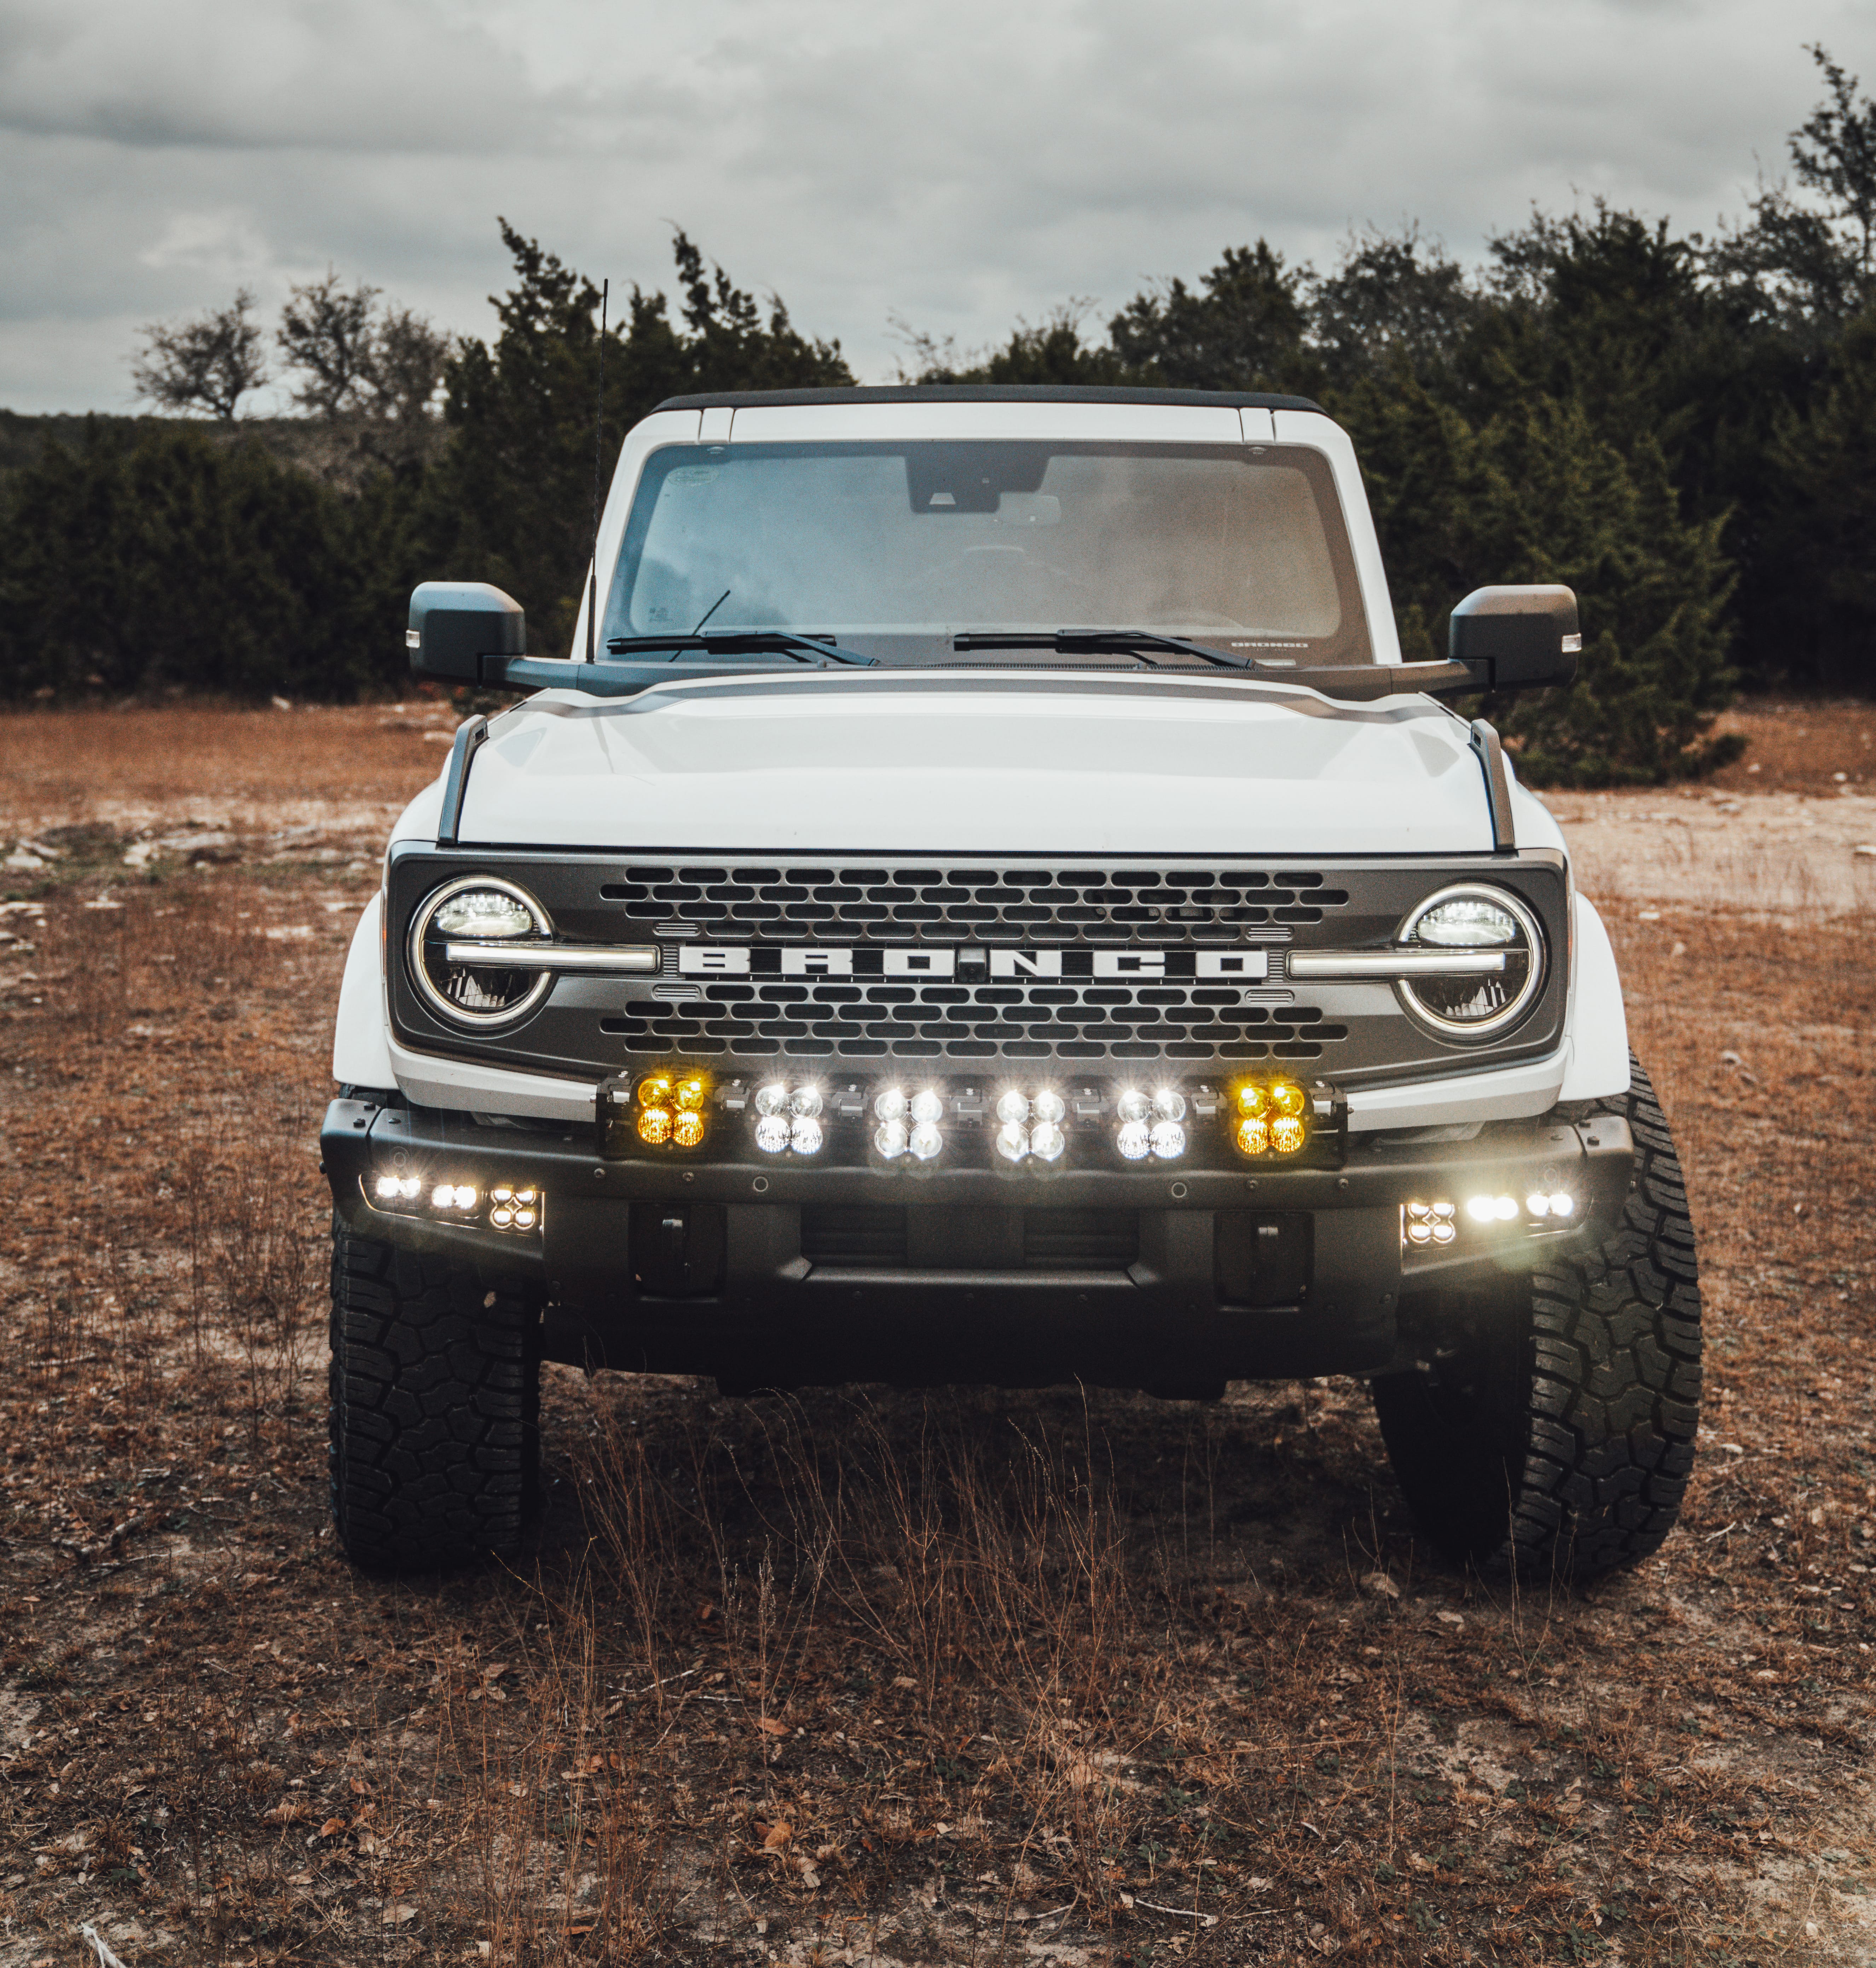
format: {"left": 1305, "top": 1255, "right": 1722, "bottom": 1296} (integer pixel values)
{"left": 321, "top": 388, "right": 1701, "bottom": 1576}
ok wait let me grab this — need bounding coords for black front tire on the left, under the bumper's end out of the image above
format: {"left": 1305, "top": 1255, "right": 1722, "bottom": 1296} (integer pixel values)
{"left": 331, "top": 1222, "right": 542, "bottom": 1573}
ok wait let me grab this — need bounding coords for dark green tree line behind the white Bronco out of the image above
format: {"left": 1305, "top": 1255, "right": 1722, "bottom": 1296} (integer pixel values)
{"left": 0, "top": 49, "right": 1876, "bottom": 783}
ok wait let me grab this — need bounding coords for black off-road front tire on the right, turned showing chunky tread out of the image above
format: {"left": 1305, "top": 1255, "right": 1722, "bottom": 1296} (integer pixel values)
{"left": 1374, "top": 1053, "right": 1701, "bottom": 1580}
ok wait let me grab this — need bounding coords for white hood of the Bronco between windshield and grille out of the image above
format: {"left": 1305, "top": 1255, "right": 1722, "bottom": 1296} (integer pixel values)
{"left": 431, "top": 671, "right": 1522, "bottom": 856}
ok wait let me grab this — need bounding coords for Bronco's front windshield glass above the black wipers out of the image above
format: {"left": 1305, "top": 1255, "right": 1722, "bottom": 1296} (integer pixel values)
{"left": 601, "top": 441, "right": 1374, "bottom": 667}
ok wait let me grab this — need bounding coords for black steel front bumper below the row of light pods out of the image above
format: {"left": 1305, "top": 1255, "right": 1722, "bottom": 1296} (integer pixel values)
{"left": 321, "top": 1100, "right": 1632, "bottom": 1391}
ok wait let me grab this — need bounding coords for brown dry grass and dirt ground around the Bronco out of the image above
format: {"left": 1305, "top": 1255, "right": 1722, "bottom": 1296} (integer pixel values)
{"left": 0, "top": 705, "right": 1876, "bottom": 1968}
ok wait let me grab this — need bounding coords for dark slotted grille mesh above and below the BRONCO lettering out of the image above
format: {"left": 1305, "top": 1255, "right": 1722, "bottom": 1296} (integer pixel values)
{"left": 601, "top": 864, "right": 1348, "bottom": 1061}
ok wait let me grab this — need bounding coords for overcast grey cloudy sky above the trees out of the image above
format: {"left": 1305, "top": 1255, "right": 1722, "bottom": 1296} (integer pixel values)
{"left": 0, "top": 0, "right": 1876, "bottom": 409}
